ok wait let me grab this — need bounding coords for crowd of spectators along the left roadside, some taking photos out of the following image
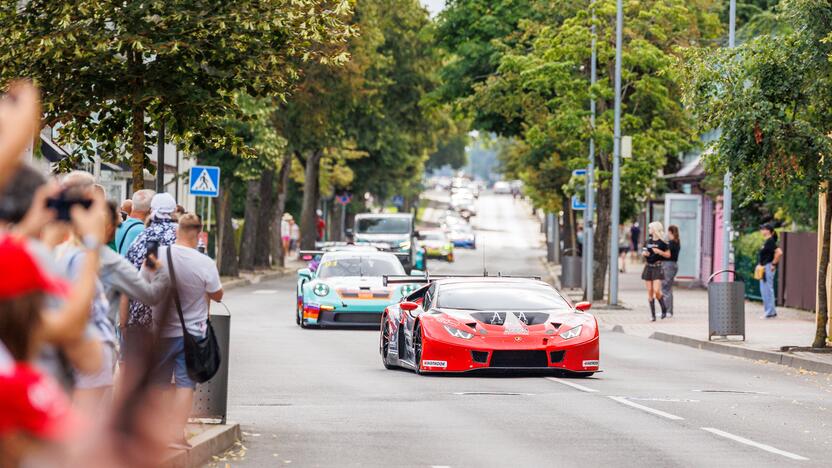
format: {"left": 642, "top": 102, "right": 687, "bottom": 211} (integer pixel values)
{"left": 0, "top": 82, "right": 222, "bottom": 468}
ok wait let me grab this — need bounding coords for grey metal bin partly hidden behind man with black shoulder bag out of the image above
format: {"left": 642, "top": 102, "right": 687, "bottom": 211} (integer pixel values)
{"left": 191, "top": 304, "right": 231, "bottom": 424}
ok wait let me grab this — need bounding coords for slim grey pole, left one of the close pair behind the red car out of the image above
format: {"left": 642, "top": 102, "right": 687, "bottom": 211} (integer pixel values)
{"left": 584, "top": 9, "right": 598, "bottom": 301}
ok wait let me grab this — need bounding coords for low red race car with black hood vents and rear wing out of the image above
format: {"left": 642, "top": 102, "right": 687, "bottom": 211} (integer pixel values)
{"left": 379, "top": 276, "right": 599, "bottom": 377}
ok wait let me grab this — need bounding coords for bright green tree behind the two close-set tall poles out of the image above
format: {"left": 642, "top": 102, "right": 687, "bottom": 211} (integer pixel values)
{"left": 458, "top": 0, "right": 719, "bottom": 299}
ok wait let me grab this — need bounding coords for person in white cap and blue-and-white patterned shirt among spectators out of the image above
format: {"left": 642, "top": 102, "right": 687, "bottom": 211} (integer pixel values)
{"left": 119, "top": 193, "right": 176, "bottom": 372}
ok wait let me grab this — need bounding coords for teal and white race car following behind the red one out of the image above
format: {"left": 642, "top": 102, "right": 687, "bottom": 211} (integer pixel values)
{"left": 295, "top": 249, "right": 423, "bottom": 328}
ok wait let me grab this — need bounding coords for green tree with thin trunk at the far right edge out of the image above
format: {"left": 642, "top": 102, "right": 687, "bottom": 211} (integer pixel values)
{"left": 682, "top": 0, "right": 832, "bottom": 347}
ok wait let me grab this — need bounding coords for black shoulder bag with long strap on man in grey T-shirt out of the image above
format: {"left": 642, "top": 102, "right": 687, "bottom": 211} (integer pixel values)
{"left": 167, "top": 245, "right": 222, "bottom": 383}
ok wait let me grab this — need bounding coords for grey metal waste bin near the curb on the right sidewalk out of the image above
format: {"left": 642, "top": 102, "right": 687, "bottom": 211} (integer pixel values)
{"left": 708, "top": 270, "right": 745, "bottom": 341}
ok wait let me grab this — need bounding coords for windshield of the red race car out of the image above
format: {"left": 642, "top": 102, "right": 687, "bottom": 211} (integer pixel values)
{"left": 436, "top": 283, "right": 569, "bottom": 311}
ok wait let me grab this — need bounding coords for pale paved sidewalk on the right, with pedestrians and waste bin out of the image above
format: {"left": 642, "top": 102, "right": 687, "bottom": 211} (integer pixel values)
{"left": 544, "top": 260, "right": 832, "bottom": 373}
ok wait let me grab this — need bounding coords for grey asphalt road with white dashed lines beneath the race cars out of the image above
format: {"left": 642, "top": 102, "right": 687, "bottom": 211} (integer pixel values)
{"left": 221, "top": 194, "right": 832, "bottom": 468}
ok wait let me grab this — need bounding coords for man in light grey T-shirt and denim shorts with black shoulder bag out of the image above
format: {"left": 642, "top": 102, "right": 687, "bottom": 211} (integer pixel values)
{"left": 142, "top": 213, "right": 223, "bottom": 448}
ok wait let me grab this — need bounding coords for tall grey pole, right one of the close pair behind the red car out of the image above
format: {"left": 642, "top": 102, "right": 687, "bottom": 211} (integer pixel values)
{"left": 610, "top": 0, "right": 624, "bottom": 305}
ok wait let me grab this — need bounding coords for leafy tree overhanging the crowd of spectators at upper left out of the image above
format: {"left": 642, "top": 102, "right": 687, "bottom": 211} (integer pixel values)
{"left": 0, "top": 0, "right": 351, "bottom": 190}
